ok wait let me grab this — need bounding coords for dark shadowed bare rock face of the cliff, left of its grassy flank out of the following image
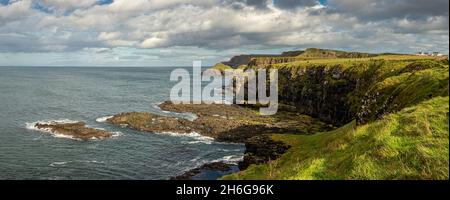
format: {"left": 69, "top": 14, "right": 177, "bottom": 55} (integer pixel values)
{"left": 279, "top": 66, "right": 356, "bottom": 125}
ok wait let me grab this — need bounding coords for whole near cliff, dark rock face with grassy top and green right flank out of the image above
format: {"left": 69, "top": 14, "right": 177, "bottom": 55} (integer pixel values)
{"left": 248, "top": 60, "right": 448, "bottom": 125}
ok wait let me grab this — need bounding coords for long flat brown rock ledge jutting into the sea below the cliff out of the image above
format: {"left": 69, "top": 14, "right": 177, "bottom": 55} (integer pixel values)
{"left": 107, "top": 102, "right": 330, "bottom": 143}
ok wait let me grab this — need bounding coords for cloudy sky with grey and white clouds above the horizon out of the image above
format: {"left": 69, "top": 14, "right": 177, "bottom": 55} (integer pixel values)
{"left": 0, "top": 0, "right": 449, "bottom": 66}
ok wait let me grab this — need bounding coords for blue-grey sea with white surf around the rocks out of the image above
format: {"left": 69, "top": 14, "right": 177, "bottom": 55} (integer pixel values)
{"left": 0, "top": 67, "right": 245, "bottom": 180}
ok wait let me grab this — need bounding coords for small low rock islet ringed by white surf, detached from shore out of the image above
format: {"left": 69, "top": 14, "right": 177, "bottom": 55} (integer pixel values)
{"left": 34, "top": 122, "right": 112, "bottom": 140}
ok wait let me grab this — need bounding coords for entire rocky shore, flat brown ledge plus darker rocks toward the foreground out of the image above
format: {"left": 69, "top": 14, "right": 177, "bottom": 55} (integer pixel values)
{"left": 103, "top": 101, "right": 332, "bottom": 179}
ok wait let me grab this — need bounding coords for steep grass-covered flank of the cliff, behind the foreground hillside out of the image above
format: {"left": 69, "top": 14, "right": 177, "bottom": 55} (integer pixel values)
{"left": 353, "top": 62, "right": 449, "bottom": 121}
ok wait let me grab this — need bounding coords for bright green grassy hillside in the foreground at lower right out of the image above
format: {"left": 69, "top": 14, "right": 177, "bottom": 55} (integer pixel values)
{"left": 224, "top": 97, "right": 449, "bottom": 180}
